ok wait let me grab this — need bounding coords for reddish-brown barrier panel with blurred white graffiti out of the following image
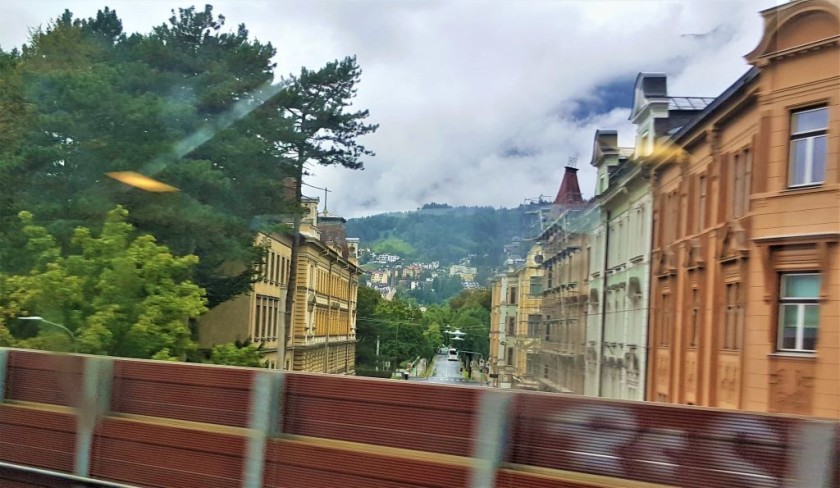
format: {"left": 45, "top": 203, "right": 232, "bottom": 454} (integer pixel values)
{"left": 508, "top": 393, "right": 797, "bottom": 487}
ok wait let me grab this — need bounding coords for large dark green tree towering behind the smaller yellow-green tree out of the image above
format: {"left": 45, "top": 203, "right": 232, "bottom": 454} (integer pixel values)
{"left": 0, "top": 5, "right": 287, "bottom": 305}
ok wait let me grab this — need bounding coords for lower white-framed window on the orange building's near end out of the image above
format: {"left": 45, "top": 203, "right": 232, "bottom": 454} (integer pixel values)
{"left": 778, "top": 273, "right": 820, "bottom": 351}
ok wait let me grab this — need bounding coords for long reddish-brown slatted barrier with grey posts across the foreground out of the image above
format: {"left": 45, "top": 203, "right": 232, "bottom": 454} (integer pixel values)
{"left": 0, "top": 348, "right": 840, "bottom": 488}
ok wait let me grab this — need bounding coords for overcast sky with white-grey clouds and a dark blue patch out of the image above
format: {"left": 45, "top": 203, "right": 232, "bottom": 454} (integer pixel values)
{"left": 0, "top": 0, "right": 782, "bottom": 217}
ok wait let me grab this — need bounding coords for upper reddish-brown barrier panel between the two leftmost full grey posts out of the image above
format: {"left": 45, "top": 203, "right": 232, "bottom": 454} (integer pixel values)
{"left": 111, "top": 360, "right": 254, "bottom": 427}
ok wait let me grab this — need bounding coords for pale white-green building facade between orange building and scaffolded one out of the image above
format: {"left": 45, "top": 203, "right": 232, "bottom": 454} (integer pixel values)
{"left": 586, "top": 131, "right": 656, "bottom": 400}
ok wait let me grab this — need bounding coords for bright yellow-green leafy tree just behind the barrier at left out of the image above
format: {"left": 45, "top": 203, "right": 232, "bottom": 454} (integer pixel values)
{"left": 0, "top": 207, "right": 206, "bottom": 360}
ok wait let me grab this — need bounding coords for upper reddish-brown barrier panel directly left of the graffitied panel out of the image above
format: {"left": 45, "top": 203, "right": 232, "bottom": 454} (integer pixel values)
{"left": 283, "top": 374, "right": 480, "bottom": 456}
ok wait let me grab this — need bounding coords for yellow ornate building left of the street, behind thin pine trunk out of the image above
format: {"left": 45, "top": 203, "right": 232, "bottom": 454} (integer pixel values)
{"left": 203, "top": 198, "right": 362, "bottom": 374}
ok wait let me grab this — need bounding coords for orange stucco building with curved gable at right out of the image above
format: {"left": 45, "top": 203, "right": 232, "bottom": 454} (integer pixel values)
{"left": 647, "top": 0, "right": 840, "bottom": 418}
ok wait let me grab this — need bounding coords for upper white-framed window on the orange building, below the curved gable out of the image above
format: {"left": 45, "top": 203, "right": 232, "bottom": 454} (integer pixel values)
{"left": 788, "top": 107, "right": 828, "bottom": 187}
